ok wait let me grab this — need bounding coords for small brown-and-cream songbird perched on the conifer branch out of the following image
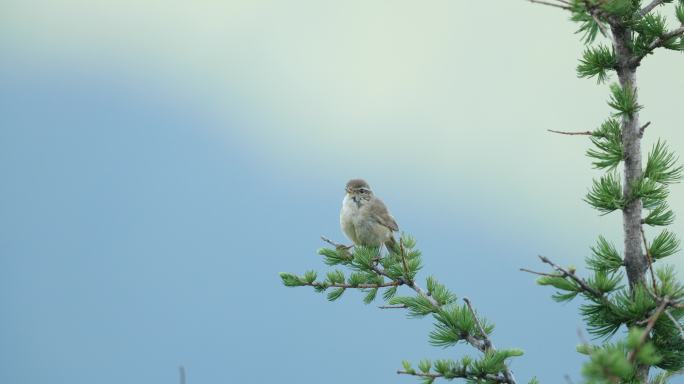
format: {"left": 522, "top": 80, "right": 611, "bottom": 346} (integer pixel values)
{"left": 340, "top": 179, "right": 399, "bottom": 250}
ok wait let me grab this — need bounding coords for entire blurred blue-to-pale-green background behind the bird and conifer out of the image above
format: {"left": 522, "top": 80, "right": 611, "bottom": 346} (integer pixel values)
{"left": 0, "top": 0, "right": 684, "bottom": 384}
